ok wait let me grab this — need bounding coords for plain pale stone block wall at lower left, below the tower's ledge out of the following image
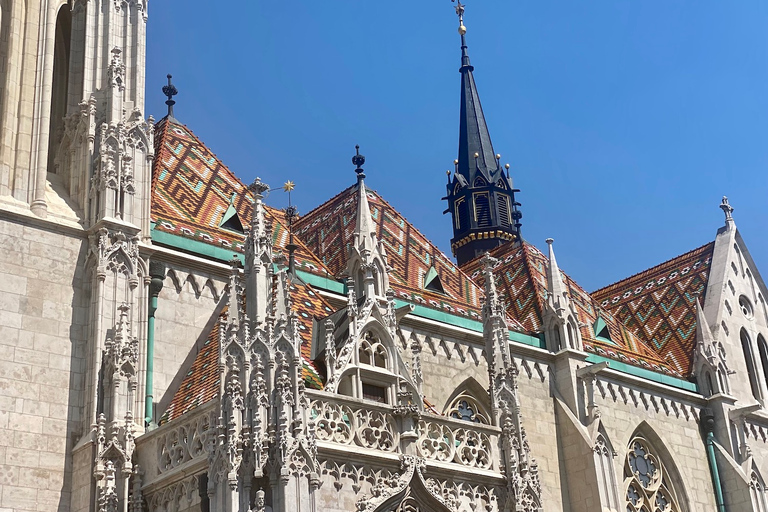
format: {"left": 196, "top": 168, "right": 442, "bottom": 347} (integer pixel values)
{"left": 0, "top": 211, "right": 89, "bottom": 512}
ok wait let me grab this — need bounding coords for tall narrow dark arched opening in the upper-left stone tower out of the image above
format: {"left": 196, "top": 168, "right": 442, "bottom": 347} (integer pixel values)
{"left": 48, "top": 4, "right": 72, "bottom": 172}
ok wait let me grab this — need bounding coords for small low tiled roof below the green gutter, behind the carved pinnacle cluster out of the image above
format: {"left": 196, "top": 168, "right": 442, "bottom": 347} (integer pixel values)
{"left": 160, "top": 280, "right": 332, "bottom": 423}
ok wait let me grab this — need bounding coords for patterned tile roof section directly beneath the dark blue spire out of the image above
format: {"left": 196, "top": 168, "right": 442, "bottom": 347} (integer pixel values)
{"left": 462, "top": 242, "right": 681, "bottom": 376}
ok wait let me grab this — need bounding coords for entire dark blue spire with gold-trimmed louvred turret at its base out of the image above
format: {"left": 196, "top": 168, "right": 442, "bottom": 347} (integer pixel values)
{"left": 443, "top": 0, "right": 522, "bottom": 265}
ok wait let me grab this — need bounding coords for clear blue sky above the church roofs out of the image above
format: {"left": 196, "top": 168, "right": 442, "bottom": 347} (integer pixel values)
{"left": 147, "top": 0, "right": 768, "bottom": 290}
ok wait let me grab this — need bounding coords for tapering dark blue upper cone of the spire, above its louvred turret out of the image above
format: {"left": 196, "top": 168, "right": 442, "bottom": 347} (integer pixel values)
{"left": 456, "top": 1, "right": 502, "bottom": 184}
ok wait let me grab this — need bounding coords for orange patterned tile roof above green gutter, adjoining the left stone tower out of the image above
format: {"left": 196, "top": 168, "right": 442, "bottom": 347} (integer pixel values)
{"left": 151, "top": 118, "right": 330, "bottom": 277}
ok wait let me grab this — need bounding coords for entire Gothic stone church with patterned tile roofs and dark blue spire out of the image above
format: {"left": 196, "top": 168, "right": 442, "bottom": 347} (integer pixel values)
{"left": 0, "top": 0, "right": 768, "bottom": 512}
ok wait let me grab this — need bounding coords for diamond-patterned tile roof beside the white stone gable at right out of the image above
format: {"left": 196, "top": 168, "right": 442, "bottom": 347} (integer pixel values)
{"left": 592, "top": 242, "right": 715, "bottom": 376}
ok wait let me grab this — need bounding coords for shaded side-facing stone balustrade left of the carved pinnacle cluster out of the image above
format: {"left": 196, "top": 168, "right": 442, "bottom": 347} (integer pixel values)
{"left": 136, "top": 401, "right": 218, "bottom": 485}
